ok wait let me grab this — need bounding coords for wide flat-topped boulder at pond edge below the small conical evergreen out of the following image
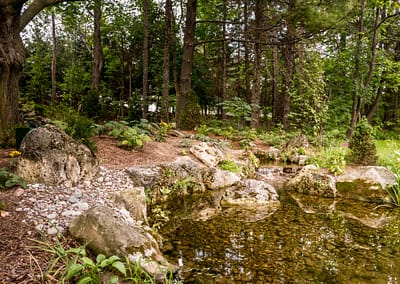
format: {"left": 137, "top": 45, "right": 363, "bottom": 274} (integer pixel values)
{"left": 336, "top": 166, "right": 396, "bottom": 202}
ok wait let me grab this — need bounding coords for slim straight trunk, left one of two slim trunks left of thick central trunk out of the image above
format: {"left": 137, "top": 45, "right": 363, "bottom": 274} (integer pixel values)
{"left": 142, "top": 0, "right": 149, "bottom": 119}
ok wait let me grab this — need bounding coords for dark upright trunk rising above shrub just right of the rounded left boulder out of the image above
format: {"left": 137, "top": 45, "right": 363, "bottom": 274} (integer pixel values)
{"left": 92, "top": 0, "right": 104, "bottom": 95}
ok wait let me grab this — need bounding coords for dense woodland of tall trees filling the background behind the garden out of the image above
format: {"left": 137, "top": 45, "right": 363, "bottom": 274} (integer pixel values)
{"left": 0, "top": 0, "right": 400, "bottom": 143}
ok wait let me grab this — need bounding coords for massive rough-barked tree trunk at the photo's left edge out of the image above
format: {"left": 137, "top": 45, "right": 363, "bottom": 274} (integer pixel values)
{"left": 0, "top": 1, "right": 26, "bottom": 144}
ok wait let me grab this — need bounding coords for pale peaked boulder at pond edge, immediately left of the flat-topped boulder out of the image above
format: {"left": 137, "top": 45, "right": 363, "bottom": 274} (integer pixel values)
{"left": 286, "top": 165, "right": 338, "bottom": 197}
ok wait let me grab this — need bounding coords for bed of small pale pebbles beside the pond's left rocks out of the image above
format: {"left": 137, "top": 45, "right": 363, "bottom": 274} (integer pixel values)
{"left": 16, "top": 167, "right": 133, "bottom": 236}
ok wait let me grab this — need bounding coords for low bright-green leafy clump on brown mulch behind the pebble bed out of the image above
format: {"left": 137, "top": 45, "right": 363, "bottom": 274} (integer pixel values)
{"left": 103, "top": 121, "right": 151, "bottom": 149}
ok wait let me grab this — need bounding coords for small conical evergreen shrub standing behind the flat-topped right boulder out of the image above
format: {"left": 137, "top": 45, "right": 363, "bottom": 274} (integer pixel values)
{"left": 349, "top": 118, "right": 378, "bottom": 165}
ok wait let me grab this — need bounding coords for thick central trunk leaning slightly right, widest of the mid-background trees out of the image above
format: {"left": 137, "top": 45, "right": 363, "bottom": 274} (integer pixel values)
{"left": 176, "top": 0, "right": 197, "bottom": 129}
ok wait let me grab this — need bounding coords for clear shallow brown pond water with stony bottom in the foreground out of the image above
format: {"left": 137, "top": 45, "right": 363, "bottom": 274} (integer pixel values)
{"left": 163, "top": 191, "right": 400, "bottom": 283}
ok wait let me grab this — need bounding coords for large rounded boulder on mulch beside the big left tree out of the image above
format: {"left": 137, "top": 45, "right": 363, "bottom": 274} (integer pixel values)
{"left": 16, "top": 124, "right": 99, "bottom": 186}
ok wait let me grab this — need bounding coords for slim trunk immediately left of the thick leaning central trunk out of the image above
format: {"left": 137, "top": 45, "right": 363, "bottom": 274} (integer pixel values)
{"left": 161, "top": 0, "right": 172, "bottom": 122}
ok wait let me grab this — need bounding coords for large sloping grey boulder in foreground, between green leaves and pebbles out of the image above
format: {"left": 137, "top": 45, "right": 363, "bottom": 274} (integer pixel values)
{"left": 69, "top": 206, "right": 177, "bottom": 278}
